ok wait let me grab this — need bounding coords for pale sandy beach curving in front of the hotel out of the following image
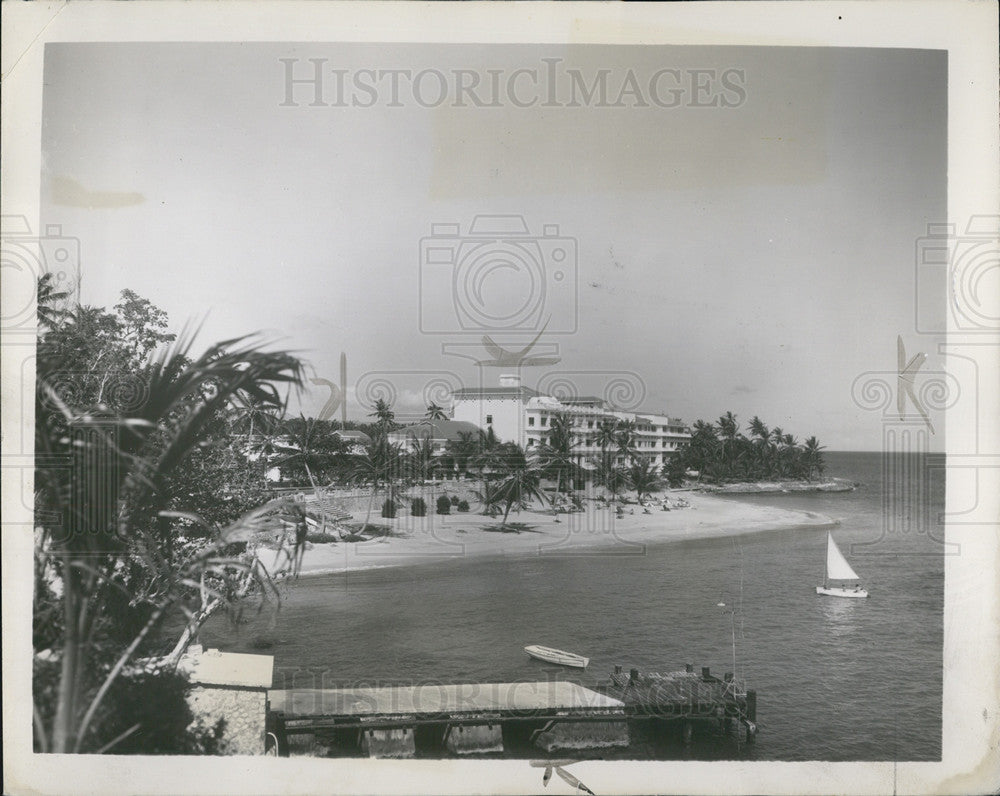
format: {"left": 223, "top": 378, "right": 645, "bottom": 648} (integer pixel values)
{"left": 284, "top": 493, "right": 835, "bottom": 575}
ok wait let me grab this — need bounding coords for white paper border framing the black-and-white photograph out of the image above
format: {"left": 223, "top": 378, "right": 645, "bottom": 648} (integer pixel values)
{"left": 2, "top": 0, "right": 1000, "bottom": 794}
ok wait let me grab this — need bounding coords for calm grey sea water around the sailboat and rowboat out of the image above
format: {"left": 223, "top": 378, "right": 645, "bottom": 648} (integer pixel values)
{"left": 202, "top": 453, "right": 944, "bottom": 760}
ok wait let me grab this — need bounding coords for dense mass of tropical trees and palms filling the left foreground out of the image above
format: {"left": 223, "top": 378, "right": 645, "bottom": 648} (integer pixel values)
{"left": 33, "top": 285, "right": 302, "bottom": 753}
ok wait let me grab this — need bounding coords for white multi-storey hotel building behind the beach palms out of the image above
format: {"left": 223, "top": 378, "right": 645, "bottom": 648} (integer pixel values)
{"left": 451, "top": 375, "right": 691, "bottom": 469}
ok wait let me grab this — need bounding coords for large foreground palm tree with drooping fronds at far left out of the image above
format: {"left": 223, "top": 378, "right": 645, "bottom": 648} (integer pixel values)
{"left": 34, "top": 330, "right": 302, "bottom": 753}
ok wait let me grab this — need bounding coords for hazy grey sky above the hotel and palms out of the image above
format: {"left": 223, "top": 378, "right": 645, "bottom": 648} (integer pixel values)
{"left": 42, "top": 44, "right": 947, "bottom": 450}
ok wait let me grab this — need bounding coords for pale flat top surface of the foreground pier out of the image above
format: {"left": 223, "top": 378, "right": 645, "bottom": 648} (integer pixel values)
{"left": 268, "top": 680, "right": 624, "bottom": 717}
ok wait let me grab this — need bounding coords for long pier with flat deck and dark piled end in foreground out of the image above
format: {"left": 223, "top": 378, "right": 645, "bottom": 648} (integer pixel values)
{"left": 268, "top": 664, "right": 757, "bottom": 758}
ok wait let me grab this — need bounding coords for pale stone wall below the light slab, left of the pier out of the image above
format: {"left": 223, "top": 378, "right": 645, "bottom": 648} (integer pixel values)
{"left": 188, "top": 685, "right": 267, "bottom": 755}
